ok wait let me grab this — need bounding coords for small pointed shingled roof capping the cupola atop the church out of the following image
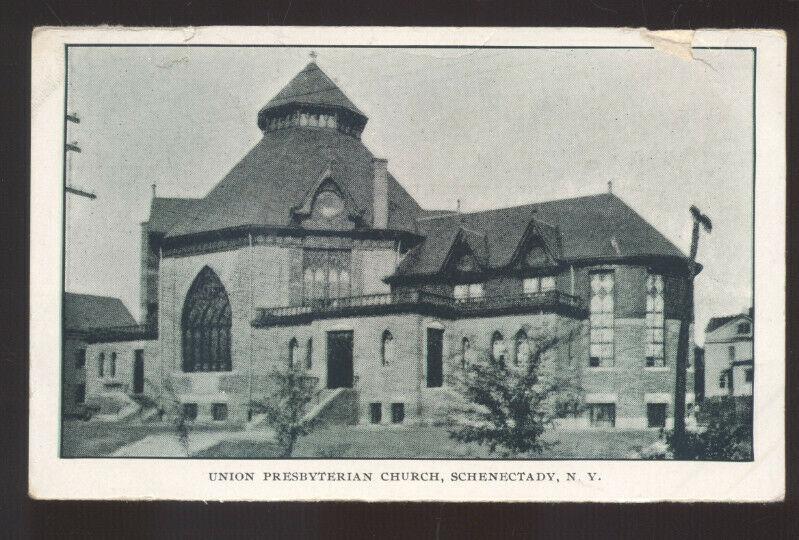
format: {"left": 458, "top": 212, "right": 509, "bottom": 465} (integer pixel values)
{"left": 259, "top": 62, "right": 366, "bottom": 119}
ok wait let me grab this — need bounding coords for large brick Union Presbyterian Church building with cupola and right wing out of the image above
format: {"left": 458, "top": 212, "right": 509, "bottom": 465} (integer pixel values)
{"left": 76, "top": 62, "right": 693, "bottom": 428}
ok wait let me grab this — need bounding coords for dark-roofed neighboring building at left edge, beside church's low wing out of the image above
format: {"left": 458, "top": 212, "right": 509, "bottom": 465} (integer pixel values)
{"left": 61, "top": 292, "right": 136, "bottom": 415}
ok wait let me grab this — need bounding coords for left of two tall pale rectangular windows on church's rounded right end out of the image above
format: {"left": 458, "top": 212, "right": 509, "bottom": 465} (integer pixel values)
{"left": 589, "top": 271, "right": 615, "bottom": 367}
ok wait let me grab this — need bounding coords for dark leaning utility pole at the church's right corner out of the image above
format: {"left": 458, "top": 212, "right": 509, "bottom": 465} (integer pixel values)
{"left": 673, "top": 206, "right": 713, "bottom": 459}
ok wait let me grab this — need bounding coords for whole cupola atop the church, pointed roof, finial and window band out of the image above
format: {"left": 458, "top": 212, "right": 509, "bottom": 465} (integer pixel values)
{"left": 258, "top": 58, "right": 368, "bottom": 138}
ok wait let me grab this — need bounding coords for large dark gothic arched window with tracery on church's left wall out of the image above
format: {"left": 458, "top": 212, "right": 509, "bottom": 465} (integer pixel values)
{"left": 182, "top": 266, "right": 232, "bottom": 372}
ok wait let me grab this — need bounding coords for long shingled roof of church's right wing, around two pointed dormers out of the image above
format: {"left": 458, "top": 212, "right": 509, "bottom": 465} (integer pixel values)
{"left": 394, "top": 193, "right": 685, "bottom": 277}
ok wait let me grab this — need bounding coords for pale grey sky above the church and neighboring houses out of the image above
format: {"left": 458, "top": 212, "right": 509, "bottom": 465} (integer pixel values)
{"left": 64, "top": 47, "right": 753, "bottom": 344}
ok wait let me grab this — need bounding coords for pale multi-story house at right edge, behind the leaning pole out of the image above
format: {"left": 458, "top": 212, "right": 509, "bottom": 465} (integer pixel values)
{"left": 705, "top": 309, "right": 755, "bottom": 397}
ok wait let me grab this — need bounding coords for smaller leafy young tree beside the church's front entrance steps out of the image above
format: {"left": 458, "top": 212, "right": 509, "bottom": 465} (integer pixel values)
{"left": 251, "top": 365, "right": 319, "bottom": 458}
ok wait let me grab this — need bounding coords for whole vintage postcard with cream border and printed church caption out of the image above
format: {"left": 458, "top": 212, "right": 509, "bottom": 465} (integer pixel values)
{"left": 30, "top": 27, "right": 786, "bottom": 501}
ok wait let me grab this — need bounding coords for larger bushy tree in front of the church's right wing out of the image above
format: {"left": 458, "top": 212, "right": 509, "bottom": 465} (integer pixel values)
{"left": 448, "top": 327, "right": 580, "bottom": 457}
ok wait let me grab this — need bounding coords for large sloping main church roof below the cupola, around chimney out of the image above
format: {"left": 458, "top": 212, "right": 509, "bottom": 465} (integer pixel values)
{"left": 167, "top": 128, "right": 421, "bottom": 237}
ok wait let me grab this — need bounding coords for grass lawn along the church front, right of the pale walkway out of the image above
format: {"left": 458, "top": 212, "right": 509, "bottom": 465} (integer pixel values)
{"left": 196, "top": 426, "right": 658, "bottom": 459}
